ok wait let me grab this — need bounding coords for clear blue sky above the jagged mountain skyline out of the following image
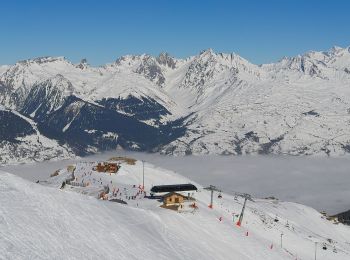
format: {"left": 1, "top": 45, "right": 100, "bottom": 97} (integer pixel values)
{"left": 0, "top": 0, "right": 350, "bottom": 65}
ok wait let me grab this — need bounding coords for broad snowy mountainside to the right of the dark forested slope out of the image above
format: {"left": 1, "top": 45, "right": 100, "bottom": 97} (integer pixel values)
{"left": 163, "top": 46, "right": 350, "bottom": 155}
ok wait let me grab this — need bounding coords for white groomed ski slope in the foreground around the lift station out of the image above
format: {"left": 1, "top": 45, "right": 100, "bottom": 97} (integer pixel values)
{"left": 0, "top": 157, "right": 350, "bottom": 260}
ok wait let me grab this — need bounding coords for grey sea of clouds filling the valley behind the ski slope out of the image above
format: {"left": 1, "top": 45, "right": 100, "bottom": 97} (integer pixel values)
{"left": 1, "top": 151, "right": 350, "bottom": 214}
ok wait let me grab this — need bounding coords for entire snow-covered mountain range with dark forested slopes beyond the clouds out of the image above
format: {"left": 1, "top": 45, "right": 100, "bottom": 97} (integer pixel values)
{"left": 0, "top": 47, "right": 350, "bottom": 161}
